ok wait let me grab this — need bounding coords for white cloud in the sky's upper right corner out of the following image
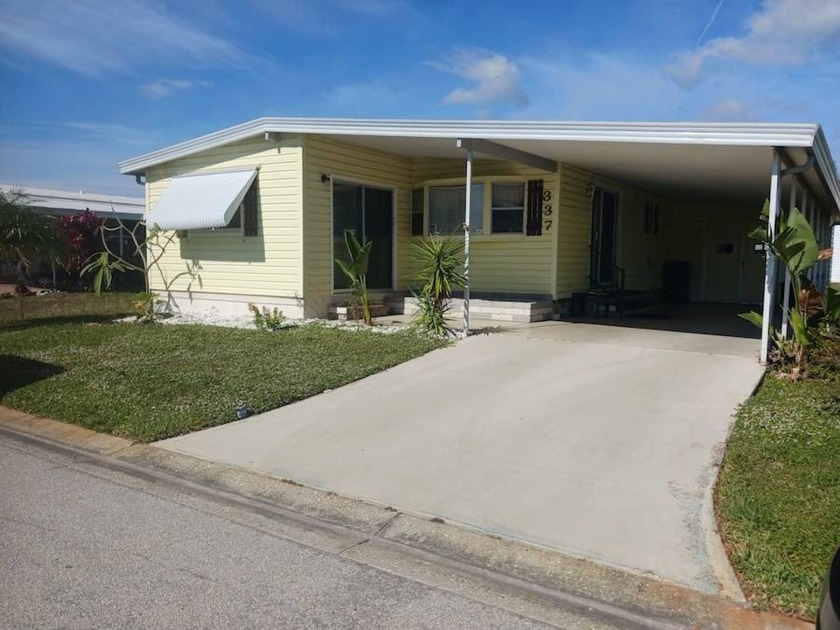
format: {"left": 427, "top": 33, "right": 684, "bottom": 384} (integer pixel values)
{"left": 666, "top": 0, "right": 840, "bottom": 87}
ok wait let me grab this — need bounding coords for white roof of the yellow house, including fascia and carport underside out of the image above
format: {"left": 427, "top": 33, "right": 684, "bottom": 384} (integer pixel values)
{"left": 119, "top": 117, "right": 840, "bottom": 213}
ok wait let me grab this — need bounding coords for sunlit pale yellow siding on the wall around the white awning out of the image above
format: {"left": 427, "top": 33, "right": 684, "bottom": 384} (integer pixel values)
{"left": 146, "top": 139, "right": 302, "bottom": 297}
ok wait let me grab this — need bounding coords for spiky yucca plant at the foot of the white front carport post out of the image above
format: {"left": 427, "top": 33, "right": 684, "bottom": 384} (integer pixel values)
{"left": 411, "top": 234, "right": 466, "bottom": 335}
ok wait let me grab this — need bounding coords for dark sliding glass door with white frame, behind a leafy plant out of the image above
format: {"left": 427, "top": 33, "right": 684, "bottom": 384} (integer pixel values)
{"left": 333, "top": 182, "right": 394, "bottom": 290}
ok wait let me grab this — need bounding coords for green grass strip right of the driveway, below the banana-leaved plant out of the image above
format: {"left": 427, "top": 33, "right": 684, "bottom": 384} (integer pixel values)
{"left": 716, "top": 362, "right": 840, "bottom": 620}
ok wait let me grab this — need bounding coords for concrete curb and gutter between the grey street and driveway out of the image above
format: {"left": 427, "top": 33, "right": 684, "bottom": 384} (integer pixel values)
{"left": 0, "top": 407, "right": 812, "bottom": 630}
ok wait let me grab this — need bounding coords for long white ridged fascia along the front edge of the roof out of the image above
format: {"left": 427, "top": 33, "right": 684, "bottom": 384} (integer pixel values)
{"left": 119, "top": 117, "right": 819, "bottom": 174}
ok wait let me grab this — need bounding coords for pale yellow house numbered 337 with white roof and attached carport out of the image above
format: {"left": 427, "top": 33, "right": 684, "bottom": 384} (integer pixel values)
{"left": 120, "top": 118, "right": 840, "bottom": 328}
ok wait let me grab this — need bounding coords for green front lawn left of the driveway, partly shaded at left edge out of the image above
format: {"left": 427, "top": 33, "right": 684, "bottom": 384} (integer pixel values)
{"left": 0, "top": 294, "right": 442, "bottom": 441}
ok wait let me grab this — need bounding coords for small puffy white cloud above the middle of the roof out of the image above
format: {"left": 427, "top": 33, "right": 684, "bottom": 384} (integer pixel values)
{"left": 431, "top": 49, "right": 528, "bottom": 106}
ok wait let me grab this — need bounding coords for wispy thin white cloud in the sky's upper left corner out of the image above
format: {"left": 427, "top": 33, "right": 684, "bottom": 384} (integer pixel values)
{"left": 0, "top": 0, "right": 254, "bottom": 77}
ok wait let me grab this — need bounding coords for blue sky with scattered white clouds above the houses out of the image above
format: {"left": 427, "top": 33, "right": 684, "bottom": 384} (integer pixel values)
{"left": 0, "top": 0, "right": 840, "bottom": 194}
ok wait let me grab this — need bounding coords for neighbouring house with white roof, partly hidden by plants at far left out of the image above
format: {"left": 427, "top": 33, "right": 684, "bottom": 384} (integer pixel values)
{"left": 0, "top": 184, "right": 146, "bottom": 279}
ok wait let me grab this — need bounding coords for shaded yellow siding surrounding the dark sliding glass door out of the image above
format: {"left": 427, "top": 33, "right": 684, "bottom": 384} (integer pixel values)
{"left": 303, "top": 135, "right": 411, "bottom": 316}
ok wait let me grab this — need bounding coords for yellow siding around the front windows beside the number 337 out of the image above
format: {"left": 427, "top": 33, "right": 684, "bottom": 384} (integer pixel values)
{"left": 412, "top": 158, "right": 562, "bottom": 295}
